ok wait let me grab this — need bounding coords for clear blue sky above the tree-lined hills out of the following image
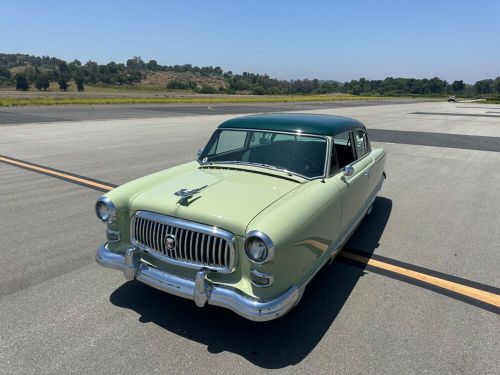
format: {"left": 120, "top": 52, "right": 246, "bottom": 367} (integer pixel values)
{"left": 0, "top": 0, "right": 500, "bottom": 83}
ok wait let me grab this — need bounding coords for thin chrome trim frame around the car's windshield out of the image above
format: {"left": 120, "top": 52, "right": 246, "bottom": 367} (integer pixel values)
{"left": 196, "top": 128, "right": 331, "bottom": 180}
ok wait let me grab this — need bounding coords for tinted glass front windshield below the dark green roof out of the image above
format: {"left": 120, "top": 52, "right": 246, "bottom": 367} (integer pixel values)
{"left": 199, "top": 129, "right": 326, "bottom": 178}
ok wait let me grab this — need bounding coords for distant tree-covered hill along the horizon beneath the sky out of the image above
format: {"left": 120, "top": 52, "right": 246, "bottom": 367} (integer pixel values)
{"left": 0, "top": 53, "right": 500, "bottom": 96}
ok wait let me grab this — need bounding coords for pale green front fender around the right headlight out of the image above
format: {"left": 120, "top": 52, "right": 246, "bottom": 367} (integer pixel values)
{"left": 246, "top": 179, "right": 342, "bottom": 298}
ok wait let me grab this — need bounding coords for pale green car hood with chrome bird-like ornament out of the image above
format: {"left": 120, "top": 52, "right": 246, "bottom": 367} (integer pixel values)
{"left": 130, "top": 168, "right": 300, "bottom": 236}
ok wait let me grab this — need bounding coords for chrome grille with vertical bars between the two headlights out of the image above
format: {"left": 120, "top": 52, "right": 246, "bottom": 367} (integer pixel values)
{"left": 131, "top": 211, "right": 234, "bottom": 273}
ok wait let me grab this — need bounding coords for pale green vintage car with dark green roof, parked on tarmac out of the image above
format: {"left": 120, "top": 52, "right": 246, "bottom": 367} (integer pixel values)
{"left": 96, "top": 114, "right": 386, "bottom": 321}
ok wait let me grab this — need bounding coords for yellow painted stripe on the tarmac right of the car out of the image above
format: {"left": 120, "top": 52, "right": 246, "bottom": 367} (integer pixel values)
{"left": 339, "top": 252, "right": 500, "bottom": 307}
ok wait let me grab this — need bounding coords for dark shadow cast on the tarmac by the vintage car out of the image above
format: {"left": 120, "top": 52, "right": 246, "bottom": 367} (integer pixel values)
{"left": 110, "top": 197, "right": 392, "bottom": 369}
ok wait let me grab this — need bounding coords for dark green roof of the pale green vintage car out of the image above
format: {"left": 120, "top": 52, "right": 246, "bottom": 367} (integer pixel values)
{"left": 219, "top": 113, "right": 365, "bottom": 136}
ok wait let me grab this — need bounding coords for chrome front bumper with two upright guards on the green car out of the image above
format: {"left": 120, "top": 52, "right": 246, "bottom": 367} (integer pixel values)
{"left": 96, "top": 245, "right": 301, "bottom": 321}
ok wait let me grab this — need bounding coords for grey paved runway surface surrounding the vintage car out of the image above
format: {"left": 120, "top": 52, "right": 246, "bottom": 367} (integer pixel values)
{"left": 0, "top": 103, "right": 500, "bottom": 374}
